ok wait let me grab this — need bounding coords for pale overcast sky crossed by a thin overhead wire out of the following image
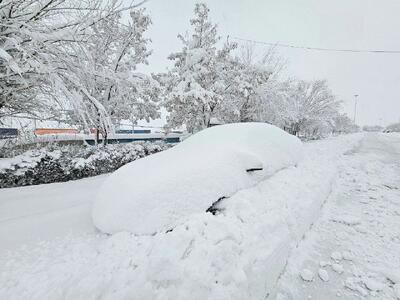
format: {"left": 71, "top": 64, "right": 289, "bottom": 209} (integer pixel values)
{"left": 135, "top": 0, "right": 400, "bottom": 125}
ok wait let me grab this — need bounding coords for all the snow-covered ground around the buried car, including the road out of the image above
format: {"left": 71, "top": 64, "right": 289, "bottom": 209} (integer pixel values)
{"left": 0, "top": 134, "right": 400, "bottom": 300}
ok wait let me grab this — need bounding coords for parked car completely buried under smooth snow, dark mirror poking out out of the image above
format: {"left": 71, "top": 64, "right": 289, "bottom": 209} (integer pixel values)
{"left": 93, "top": 123, "right": 302, "bottom": 234}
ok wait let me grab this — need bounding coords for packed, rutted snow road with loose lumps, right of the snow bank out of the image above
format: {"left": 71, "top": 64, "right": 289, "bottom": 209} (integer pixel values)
{"left": 277, "top": 134, "right": 400, "bottom": 300}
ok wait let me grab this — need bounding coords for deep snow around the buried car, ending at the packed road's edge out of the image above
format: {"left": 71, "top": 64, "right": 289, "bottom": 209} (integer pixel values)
{"left": 0, "top": 135, "right": 363, "bottom": 300}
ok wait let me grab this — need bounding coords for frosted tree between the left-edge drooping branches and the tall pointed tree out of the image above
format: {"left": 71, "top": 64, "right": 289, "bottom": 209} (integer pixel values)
{"left": 69, "top": 3, "right": 160, "bottom": 142}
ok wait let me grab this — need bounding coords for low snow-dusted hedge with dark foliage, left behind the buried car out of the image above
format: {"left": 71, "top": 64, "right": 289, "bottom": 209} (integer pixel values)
{"left": 0, "top": 142, "right": 169, "bottom": 188}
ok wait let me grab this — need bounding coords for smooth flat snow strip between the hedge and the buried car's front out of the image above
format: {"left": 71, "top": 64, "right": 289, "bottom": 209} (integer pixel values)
{"left": 0, "top": 175, "right": 107, "bottom": 255}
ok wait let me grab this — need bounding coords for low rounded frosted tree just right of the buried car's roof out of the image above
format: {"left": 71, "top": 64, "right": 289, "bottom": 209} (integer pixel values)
{"left": 258, "top": 79, "right": 347, "bottom": 137}
